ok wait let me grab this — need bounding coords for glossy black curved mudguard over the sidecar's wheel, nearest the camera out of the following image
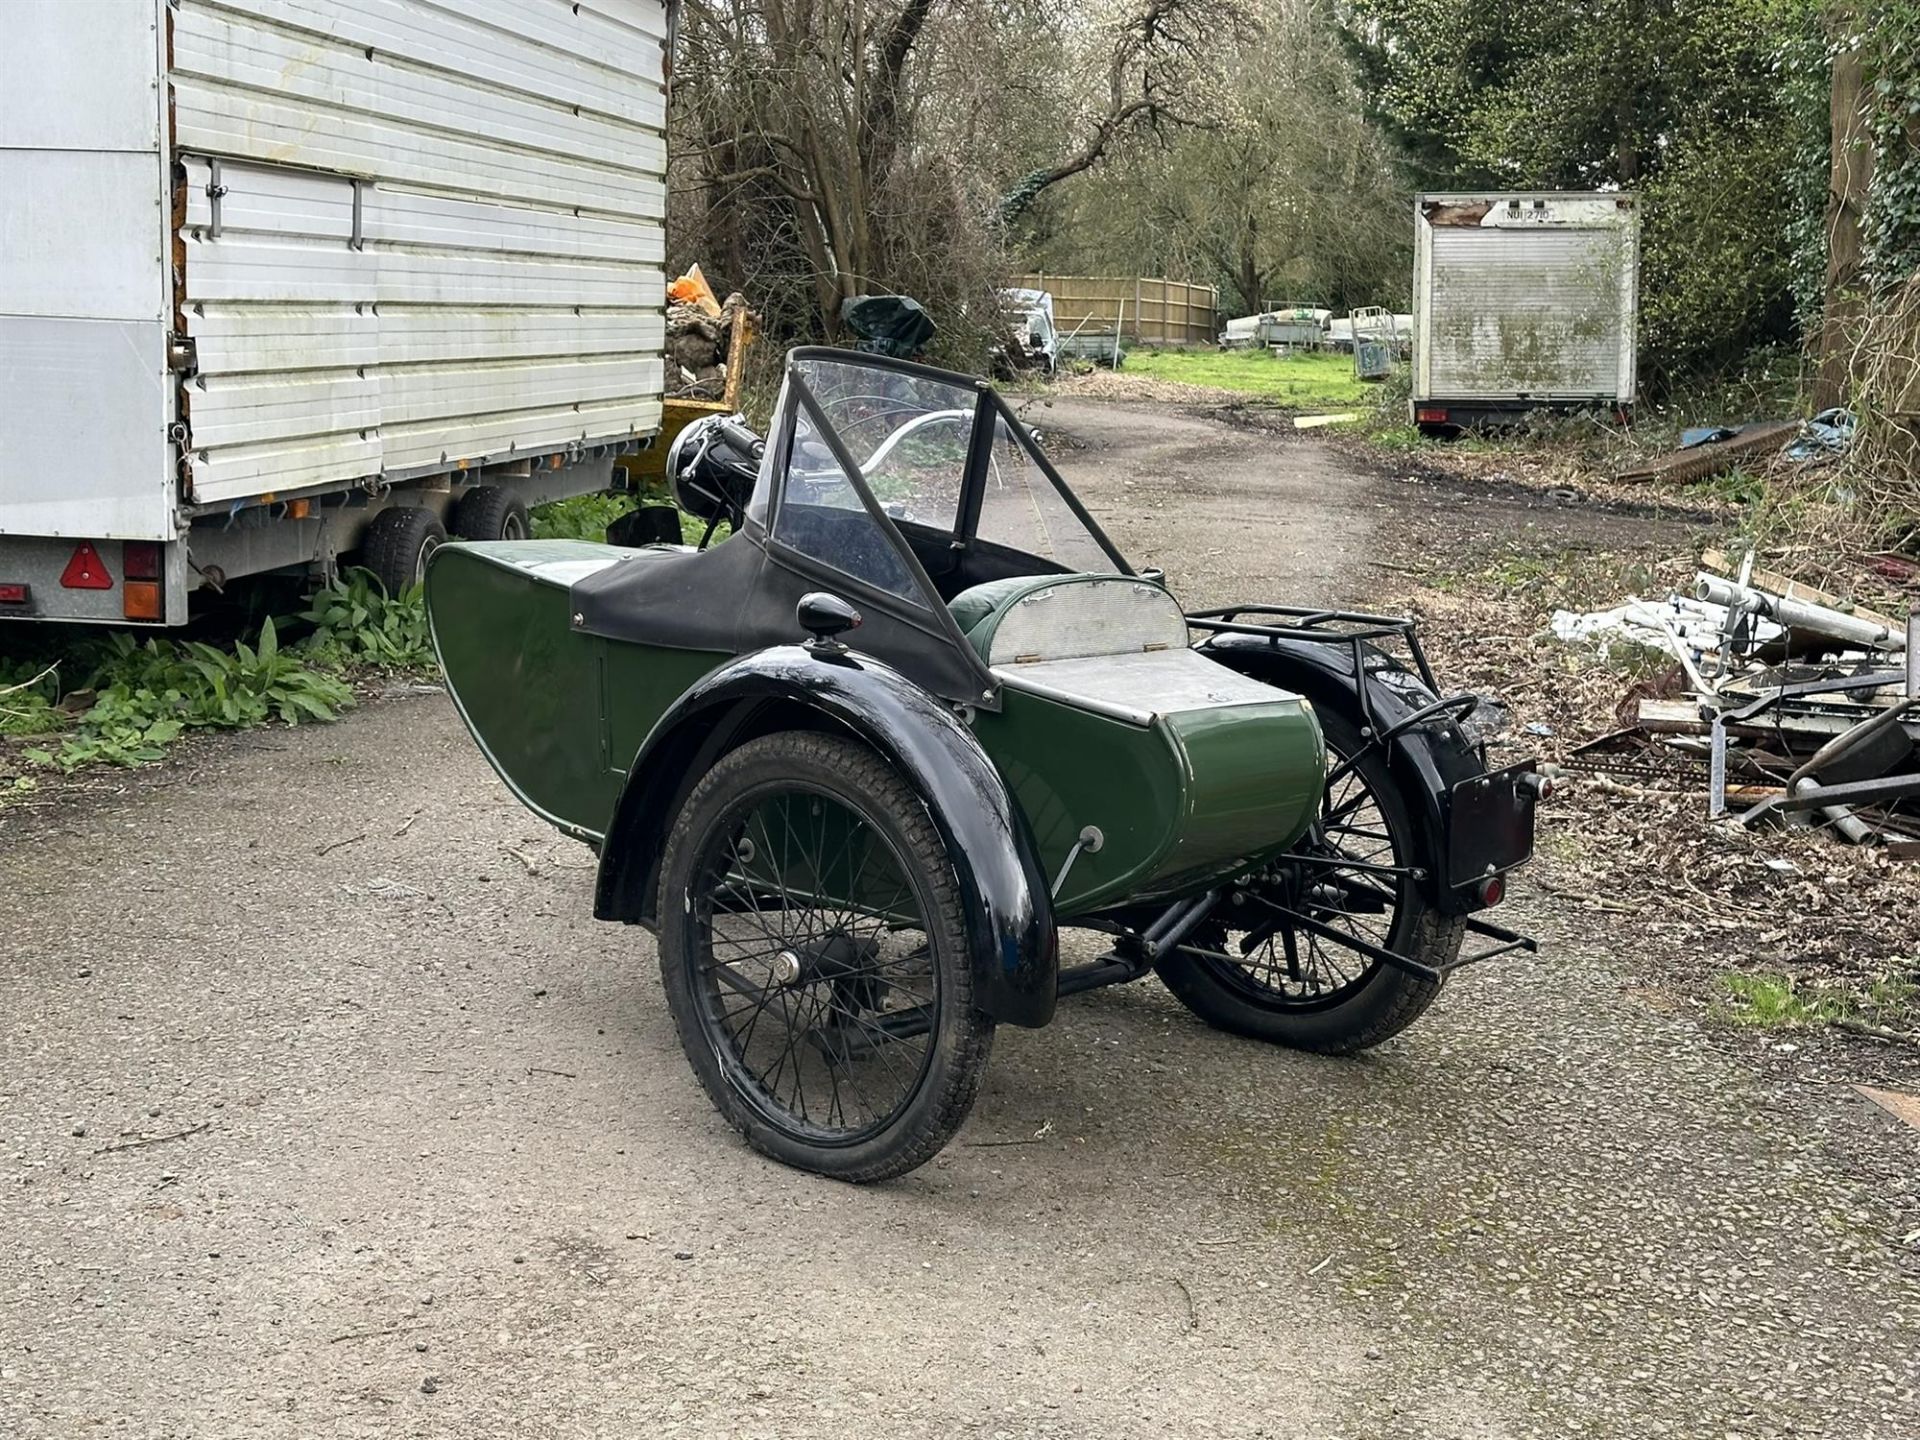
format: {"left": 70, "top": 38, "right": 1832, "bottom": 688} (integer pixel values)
{"left": 593, "top": 645, "right": 1060, "bottom": 1025}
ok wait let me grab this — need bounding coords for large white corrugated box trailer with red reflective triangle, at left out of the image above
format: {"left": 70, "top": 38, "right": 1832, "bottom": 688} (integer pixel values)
{"left": 0, "top": 0, "right": 670, "bottom": 624}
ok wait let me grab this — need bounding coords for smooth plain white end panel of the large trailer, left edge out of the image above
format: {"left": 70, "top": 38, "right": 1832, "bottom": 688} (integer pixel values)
{"left": 0, "top": 0, "right": 173, "bottom": 545}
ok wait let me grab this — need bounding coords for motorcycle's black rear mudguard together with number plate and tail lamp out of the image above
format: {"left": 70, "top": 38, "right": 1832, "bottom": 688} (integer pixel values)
{"left": 1202, "top": 634, "right": 1534, "bottom": 914}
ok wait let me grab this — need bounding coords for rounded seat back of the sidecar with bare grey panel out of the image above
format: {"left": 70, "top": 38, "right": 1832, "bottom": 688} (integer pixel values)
{"left": 948, "top": 574, "right": 1188, "bottom": 664}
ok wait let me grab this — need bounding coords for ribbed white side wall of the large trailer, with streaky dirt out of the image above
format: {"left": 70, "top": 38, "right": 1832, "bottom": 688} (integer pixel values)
{"left": 169, "top": 0, "right": 666, "bottom": 503}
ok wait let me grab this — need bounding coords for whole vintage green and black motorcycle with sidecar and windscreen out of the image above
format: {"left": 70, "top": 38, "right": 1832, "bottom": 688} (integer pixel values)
{"left": 426, "top": 348, "right": 1548, "bottom": 1181}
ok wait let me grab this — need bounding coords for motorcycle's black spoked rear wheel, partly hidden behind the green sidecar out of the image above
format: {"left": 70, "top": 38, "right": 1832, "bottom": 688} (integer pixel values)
{"left": 1156, "top": 707, "right": 1465, "bottom": 1054}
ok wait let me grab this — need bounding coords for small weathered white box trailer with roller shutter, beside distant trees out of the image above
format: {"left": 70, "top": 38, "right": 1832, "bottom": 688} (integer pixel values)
{"left": 1413, "top": 192, "right": 1640, "bottom": 432}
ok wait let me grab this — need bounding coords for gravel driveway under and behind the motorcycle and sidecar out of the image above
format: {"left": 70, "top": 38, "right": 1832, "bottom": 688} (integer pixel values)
{"left": 0, "top": 403, "right": 1920, "bottom": 1440}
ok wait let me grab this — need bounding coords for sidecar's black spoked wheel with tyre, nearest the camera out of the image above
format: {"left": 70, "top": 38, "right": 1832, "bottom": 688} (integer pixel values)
{"left": 659, "top": 732, "right": 993, "bottom": 1183}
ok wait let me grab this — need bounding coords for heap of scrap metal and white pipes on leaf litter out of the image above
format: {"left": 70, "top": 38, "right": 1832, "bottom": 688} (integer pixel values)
{"left": 1553, "top": 551, "right": 1920, "bottom": 858}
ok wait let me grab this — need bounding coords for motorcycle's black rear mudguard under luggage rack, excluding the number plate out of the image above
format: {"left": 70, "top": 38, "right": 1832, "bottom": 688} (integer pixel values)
{"left": 1202, "top": 634, "right": 1486, "bottom": 914}
